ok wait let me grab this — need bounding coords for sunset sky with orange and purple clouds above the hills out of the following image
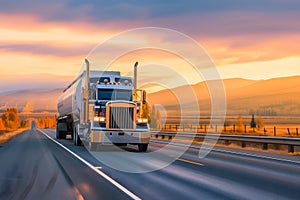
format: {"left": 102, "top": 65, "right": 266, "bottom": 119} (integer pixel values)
{"left": 0, "top": 0, "right": 300, "bottom": 91}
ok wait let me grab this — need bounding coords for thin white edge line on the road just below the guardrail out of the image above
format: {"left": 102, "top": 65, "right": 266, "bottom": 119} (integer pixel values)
{"left": 151, "top": 140, "right": 300, "bottom": 164}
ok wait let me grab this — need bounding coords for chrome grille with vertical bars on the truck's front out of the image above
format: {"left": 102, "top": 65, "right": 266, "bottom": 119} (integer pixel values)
{"left": 109, "top": 107, "right": 134, "bottom": 129}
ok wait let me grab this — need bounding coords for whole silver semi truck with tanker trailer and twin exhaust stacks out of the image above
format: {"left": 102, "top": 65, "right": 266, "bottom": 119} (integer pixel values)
{"left": 56, "top": 59, "right": 150, "bottom": 152}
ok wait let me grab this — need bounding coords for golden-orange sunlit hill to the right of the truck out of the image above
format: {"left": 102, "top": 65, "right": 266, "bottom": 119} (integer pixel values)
{"left": 148, "top": 76, "right": 300, "bottom": 116}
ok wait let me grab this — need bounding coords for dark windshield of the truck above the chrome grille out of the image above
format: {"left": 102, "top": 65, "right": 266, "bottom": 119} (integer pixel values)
{"left": 98, "top": 89, "right": 132, "bottom": 101}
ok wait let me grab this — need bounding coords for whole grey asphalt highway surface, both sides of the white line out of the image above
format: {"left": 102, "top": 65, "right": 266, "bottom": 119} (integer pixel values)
{"left": 0, "top": 128, "right": 300, "bottom": 199}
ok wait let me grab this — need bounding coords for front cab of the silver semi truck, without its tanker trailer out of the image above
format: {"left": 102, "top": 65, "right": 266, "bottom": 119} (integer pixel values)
{"left": 90, "top": 73, "right": 150, "bottom": 151}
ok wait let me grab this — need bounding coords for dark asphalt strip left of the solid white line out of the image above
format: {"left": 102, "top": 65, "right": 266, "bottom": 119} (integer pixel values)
{"left": 0, "top": 129, "right": 131, "bottom": 200}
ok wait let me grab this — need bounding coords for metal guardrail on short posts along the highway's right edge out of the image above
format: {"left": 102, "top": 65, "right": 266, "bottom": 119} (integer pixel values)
{"left": 151, "top": 131, "right": 300, "bottom": 153}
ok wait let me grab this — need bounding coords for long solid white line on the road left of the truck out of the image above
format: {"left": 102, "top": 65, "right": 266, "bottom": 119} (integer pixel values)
{"left": 39, "top": 130, "right": 141, "bottom": 200}
